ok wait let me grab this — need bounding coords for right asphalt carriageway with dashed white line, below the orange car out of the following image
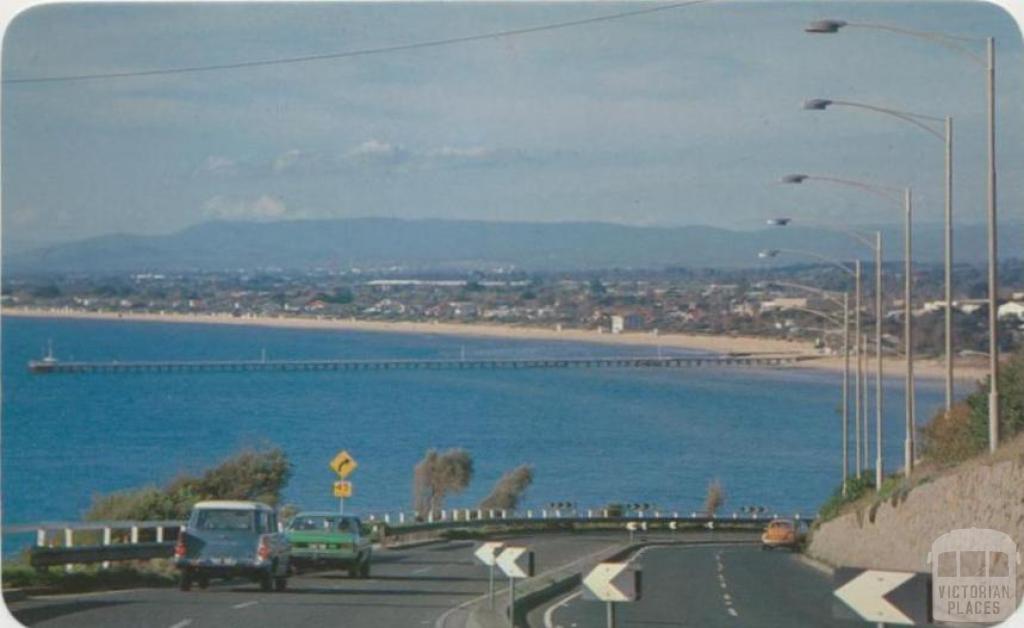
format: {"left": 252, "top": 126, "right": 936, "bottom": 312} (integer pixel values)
{"left": 529, "top": 544, "right": 836, "bottom": 628}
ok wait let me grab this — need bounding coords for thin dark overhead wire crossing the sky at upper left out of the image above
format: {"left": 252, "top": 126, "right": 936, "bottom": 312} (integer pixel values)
{"left": 3, "top": 0, "right": 712, "bottom": 85}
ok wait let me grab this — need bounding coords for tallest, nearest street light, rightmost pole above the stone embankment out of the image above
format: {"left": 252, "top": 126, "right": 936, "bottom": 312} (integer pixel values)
{"left": 804, "top": 19, "right": 999, "bottom": 451}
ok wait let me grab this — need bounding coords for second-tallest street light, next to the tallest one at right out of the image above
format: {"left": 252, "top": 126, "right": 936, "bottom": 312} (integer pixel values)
{"left": 804, "top": 98, "right": 953, "bottom": 412}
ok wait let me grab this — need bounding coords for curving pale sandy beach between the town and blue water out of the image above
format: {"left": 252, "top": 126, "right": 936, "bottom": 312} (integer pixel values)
{"left": 0, "top": 307, "right": 987, "bottom": 386}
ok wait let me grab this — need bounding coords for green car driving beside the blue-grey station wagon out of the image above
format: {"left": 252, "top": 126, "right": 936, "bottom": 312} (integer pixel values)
{"left": 285, "top": 512, "right": 373, "bottom": 578}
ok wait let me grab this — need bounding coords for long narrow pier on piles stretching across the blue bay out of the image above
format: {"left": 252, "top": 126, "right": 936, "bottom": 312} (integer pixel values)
{"left": 29, "top": 355, "right": 815, "bottom": 374}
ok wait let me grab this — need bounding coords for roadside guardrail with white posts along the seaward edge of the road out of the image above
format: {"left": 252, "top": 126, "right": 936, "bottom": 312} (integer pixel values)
{"left": 3, "top": 508, "right": 814, "bottom": 569}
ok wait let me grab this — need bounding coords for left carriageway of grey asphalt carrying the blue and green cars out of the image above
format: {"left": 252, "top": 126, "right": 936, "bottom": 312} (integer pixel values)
{"left": 8, "top": 533, "right": 626, "bottom": 628}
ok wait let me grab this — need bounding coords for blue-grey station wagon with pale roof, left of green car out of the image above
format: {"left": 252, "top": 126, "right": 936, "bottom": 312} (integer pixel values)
{"left": 174, "top": 501, "right": 291, "bottom": 591}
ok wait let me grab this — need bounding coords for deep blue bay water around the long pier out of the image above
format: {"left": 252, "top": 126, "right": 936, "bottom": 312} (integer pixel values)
{"left": 0, "top": 317, "right": 941, "bottom": 553}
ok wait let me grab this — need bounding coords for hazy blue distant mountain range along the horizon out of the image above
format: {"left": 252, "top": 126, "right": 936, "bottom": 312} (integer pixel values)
{"left": 3, "top": 218, "right": 1024, "bottom": 275}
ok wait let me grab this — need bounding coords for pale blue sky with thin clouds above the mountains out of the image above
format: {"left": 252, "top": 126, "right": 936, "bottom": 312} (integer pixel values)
{"left": 0, "top": 0, "right": 1024, "bottom": 244}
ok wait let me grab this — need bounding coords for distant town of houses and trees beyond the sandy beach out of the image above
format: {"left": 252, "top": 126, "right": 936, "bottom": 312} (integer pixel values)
{"left": 2, "top": 262, "right": 1024, "bottom": 355}
